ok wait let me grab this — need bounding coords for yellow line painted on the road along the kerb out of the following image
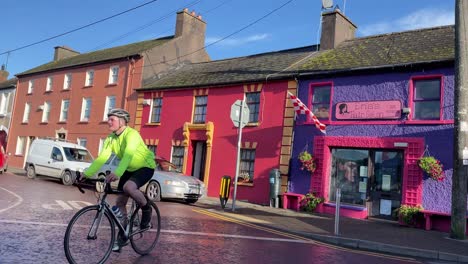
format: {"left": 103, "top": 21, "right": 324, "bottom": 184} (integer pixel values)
{"left": 192, "top": 209, "right": 421, "bottom": 263}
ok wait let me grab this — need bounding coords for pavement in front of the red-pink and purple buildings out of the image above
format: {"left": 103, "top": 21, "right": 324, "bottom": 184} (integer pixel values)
{"left": 196, "top": 197, "right": 468, "bottom": 263}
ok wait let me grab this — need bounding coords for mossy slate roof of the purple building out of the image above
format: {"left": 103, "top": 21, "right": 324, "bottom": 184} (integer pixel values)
{"left": 300, "top": 25, "right": 455, "bottom": 73}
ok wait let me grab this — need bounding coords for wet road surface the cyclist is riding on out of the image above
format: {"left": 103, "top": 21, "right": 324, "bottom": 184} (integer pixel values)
{"left": 0, "top": 173, "right": 424, "bottom": 264}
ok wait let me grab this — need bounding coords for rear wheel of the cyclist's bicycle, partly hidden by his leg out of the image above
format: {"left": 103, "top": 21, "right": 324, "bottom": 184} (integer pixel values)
{"left": 129, "top": 198, "right": 161, "bottom": 255}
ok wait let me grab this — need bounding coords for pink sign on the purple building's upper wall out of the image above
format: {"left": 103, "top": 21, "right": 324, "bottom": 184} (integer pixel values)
{"left": 335, "top": 100, "right": 401, "bottom": 119}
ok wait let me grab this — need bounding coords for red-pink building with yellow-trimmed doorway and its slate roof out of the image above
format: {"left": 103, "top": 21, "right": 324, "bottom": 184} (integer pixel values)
{"left": 136, "top": 47, "right": 315, "bottom": 204}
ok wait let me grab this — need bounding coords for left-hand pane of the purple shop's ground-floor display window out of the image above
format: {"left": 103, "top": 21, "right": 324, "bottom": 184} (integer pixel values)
{"left": 330, "top": 149, "right": 369, "bottom": 206}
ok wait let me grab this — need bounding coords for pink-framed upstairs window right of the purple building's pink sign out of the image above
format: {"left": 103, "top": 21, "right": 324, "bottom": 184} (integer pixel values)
{"left": 411, "top": 77, "right": 442, "bottom": 120}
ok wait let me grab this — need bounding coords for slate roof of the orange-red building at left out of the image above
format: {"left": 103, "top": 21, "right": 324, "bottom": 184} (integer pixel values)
{"left": 17, "top": 36, "right": 174, "bottom": 76}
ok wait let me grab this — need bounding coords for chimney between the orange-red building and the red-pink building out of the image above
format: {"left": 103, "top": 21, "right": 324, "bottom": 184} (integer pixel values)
{"left": 175, "top": 8, "right": 206, "bottom": 39}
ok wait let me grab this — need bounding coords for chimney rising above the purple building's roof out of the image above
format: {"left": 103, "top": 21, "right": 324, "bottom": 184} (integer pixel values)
{"left": 320, "top": 9, "right": 357, "bottom": 50}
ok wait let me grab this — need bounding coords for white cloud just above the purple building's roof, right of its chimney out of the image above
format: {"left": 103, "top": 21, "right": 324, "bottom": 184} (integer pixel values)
{"left": 358, "top": 8, "right": 455, "bottom": 36}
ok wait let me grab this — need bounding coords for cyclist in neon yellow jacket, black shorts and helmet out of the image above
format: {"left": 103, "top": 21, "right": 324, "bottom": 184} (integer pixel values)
{"left": 78, "top": 108, "right": 156, "bottom": 251}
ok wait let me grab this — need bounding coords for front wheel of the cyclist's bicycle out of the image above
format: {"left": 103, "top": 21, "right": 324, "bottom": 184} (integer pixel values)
{"left": 63, "top": 205, "right": 115, "bottom": 264}
